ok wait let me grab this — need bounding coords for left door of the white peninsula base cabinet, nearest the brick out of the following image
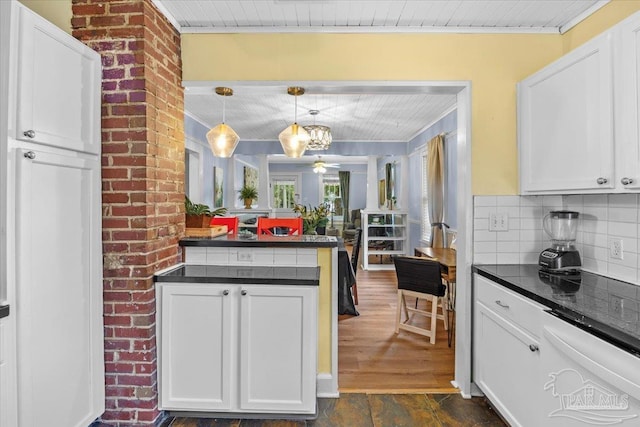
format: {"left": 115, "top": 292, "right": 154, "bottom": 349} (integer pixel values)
{"left": 159, "top": 283, "right": 235, "bottom": 411}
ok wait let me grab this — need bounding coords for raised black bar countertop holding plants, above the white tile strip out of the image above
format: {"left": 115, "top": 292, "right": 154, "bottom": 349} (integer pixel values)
{"left": 180, "top": 234, "right": 338, "bottom": 248}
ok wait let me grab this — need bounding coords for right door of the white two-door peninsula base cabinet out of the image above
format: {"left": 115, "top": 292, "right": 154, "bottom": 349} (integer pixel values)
{"left": 239, "top": 286, "right": 317, "bottom": 413}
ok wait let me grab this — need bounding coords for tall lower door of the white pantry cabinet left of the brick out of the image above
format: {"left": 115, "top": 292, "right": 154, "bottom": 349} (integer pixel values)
{"left": 11, "top": 149, "right": 105, "bottom": 426}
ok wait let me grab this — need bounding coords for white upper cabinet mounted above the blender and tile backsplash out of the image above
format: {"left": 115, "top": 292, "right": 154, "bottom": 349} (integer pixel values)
{"left": 518, "top": 13, "right": 640, "bottom": 194}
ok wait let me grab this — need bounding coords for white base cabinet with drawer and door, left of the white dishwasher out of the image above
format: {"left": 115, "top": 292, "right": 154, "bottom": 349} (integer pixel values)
{"left": 473, "top": 274, "right": 544, "bottom": 426}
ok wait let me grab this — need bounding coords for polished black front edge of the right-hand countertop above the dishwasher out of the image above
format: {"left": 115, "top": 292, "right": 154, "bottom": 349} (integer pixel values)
{"left": 472, "top": 265, "right": 640, "bottom": 357}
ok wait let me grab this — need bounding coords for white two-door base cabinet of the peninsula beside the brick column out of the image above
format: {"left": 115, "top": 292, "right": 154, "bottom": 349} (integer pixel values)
{"left": 158, "top": 283, "right": 317, "bottom": 414}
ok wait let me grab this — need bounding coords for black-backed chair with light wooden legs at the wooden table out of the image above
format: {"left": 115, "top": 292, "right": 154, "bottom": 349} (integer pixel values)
{"left": 393, "top": 256, "right": 449, "bottom": 344}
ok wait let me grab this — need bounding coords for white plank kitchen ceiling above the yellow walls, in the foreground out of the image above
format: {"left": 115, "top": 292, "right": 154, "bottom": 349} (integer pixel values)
{"left": 154, "top": 0, "right": 608, "bottom": 33}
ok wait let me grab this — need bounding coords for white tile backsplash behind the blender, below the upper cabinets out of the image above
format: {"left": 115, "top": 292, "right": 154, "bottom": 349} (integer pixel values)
{"left": 473, "top": 194, "right": 640, "bottom": 285}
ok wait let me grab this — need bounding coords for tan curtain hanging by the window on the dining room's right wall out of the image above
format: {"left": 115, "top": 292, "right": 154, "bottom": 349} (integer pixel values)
{"left": 427, "top": 135, "right": 448, "bottom": 248}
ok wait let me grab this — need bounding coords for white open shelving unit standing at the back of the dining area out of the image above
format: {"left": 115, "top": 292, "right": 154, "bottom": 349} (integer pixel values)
{"left": 362, "top": 210, "right": 408, "bottom": 270}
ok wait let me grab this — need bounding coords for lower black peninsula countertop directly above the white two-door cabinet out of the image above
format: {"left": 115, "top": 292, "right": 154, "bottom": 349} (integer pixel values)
{"left": 154, "top": 264, "right": 320, "bottom": 286}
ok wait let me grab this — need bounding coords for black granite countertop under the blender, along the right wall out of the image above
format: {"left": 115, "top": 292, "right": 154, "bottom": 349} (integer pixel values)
{"left": 473, "top": 264, "right": 640, "bottom": 356}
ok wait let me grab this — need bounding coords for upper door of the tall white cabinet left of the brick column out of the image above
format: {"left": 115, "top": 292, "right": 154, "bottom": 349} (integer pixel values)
{"left": 15, "top": 7, "right": 101, "bottom": 153}
